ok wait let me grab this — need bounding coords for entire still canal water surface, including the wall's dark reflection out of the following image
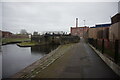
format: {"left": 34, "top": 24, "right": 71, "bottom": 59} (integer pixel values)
{"left": 2, "top": 44, "right": 58, "bottom": 78}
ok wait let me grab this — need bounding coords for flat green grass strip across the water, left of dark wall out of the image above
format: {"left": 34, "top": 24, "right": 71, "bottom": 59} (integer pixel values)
{"left": 2, "top": 38, "right": 31, "bottom": 44}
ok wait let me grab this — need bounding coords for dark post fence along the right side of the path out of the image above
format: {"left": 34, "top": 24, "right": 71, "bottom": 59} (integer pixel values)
{"left": 88, "top": 38, "right": 120, "bottom": 65}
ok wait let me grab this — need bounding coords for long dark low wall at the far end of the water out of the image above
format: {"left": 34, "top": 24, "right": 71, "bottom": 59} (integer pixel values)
{"left": 31, "top": 35, "right": 80, "bottom": 44}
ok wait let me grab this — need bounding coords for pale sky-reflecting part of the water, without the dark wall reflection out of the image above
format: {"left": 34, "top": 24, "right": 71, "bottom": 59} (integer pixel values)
{"left": 2, "top": 44, "right": 45, "bottom": 78}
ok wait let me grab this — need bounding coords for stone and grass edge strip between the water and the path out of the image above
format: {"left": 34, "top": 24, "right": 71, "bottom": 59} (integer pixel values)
{"left": 11, "top": 43, "right": 75, "bottom": 78}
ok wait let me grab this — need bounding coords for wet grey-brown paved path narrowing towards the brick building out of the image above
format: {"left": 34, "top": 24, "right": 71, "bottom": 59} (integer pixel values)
{"left": 36, "top": 39, "right": 118, "bottom": 78}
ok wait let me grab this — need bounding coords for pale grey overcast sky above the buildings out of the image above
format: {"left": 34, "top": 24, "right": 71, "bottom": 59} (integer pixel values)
{"left": 2, "top": 2, "right": 118, "bottom": 33}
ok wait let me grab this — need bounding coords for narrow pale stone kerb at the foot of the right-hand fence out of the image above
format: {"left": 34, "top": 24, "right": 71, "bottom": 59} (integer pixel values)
{"left": 89, "top": 44, "right": 120, "bottom": 76}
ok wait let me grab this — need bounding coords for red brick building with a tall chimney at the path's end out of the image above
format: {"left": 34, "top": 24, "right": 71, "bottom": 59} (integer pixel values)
{"left": 70, "top": 18, "right": 89, "bottom": 37}
